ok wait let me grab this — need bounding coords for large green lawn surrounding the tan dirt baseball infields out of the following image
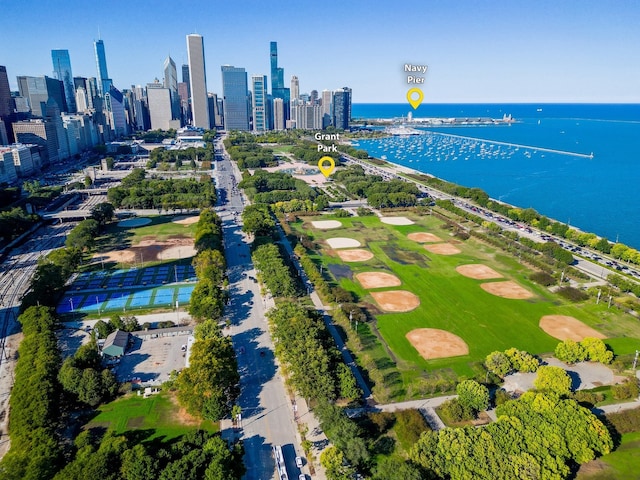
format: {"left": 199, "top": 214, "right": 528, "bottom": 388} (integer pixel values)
{"left": 292, "top": 214, "right": 640, "bottom": 383}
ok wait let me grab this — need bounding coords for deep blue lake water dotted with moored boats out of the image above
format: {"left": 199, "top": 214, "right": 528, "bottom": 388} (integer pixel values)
{"left": 352, "top": 104, "right": 640, "bottom": 249}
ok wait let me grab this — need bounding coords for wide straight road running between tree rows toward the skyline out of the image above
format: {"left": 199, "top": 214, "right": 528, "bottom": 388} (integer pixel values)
{"left": 214, "top": 139, "right": 308, "bottom": 480}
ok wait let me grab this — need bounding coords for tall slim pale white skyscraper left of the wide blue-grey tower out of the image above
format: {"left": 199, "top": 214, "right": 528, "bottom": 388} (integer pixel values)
{"left": 187, "top": 33, "right": 210, "bottom": 129}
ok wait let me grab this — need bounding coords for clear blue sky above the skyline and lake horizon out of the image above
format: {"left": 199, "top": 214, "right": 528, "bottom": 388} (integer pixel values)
{"left": 0, "top": 0, "right": 640, "bottom": 103}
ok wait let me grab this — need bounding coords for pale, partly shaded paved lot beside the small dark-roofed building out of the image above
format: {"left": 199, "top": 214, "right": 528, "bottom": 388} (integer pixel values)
{"left": 115, "top": 335, "right": 188, "bottom": 385}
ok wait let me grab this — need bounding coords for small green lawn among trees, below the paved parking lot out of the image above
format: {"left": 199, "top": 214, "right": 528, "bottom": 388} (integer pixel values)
{"left": 85, "top": 392, "right": 218, "bottom": 440}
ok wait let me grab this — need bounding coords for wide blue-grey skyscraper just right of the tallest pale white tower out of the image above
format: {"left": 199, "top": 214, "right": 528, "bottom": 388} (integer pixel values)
{"left": 221, "top": 65, "right": 249, "bottom": 130}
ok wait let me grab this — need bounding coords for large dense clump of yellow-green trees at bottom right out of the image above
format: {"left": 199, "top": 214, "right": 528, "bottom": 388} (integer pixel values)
{"left": 410, "top": 392, "right": 613, "bottom": 480}
